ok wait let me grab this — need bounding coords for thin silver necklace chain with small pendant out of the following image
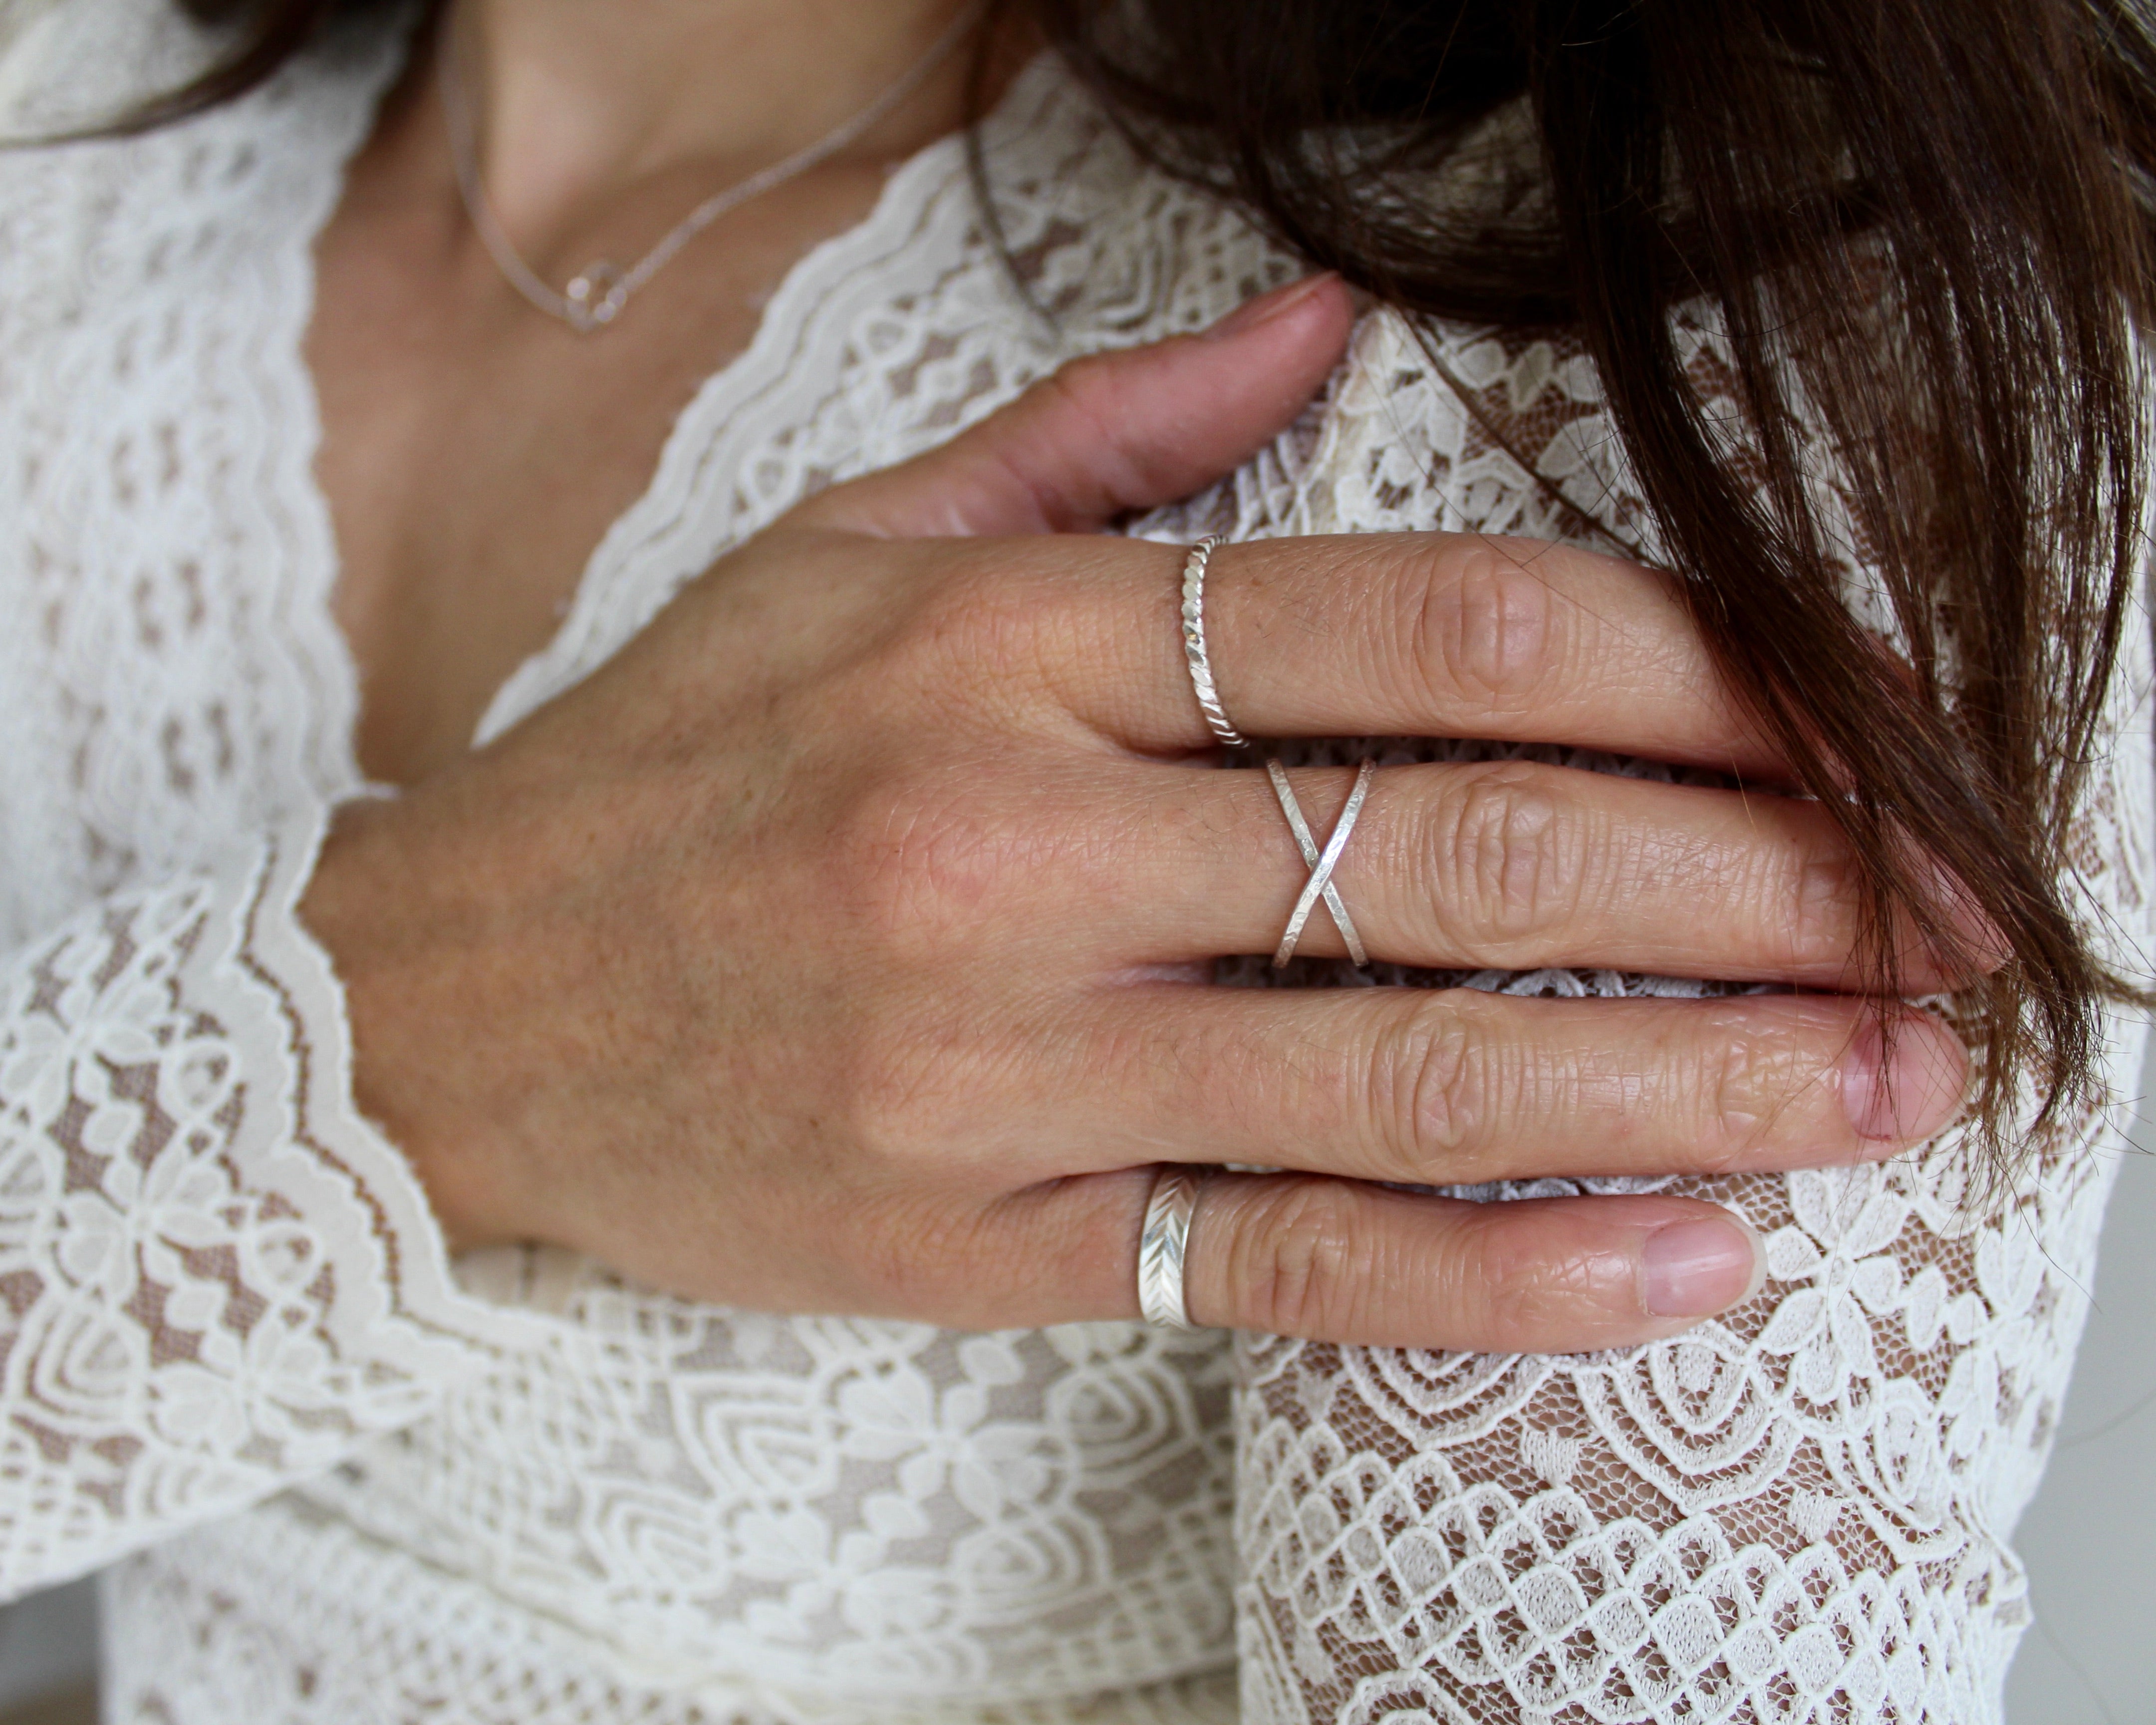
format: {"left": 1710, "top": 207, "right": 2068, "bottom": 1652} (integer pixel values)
{"left": 442, "top": 0, "right": 985, "bottom": 336}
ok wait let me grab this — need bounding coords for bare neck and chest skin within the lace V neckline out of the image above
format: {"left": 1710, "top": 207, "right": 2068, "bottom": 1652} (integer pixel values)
{"left": 308, "top": 0, "right": 1009, "bottom": 785}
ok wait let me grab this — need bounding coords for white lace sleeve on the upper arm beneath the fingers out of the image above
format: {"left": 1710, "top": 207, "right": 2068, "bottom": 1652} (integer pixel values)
{"left": 1160, "top": 319, "right": 2152, "bottom": 1725}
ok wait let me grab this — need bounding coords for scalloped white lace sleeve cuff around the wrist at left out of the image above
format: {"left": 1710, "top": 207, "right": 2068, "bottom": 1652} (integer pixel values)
{"left": 0, "top": 822, "right": 526, "bottom": 1593}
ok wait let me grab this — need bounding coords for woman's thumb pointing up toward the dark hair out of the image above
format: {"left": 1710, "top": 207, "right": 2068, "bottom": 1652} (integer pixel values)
{"left": 791, "top": 274, "right": 1354, "bottom": 539}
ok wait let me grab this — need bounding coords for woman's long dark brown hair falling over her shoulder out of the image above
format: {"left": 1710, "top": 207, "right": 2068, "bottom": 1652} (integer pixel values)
{"left": 138, "top": 0, "right": 2156, "bottom": 1166}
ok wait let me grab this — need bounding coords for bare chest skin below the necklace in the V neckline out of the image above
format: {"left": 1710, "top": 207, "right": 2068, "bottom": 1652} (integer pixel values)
{"left": 306, "top": 48, "right": 884, "bottom": 785}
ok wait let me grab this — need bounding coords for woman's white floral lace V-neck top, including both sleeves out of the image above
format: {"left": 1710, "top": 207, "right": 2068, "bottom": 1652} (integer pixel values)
{"left": 0, "top": 0, "right": 2150, "bottom": 1725}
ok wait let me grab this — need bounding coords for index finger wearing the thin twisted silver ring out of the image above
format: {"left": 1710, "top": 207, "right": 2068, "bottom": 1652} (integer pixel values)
{"left": 1061, "top": 533, "right": 1785, "bottom": 779}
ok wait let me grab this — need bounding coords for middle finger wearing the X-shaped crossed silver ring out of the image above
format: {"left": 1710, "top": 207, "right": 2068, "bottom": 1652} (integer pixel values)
{"left": 1106, "top": 761, "right": 1945, "bottom": 992}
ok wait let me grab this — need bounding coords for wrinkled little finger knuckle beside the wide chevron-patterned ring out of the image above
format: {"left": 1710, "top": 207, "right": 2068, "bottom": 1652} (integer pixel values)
{"left": 1229, "top": 1177, "right": 1369, "bottom": 1337}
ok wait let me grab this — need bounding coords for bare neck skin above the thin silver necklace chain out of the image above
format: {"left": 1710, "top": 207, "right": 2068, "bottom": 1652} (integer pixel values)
{"left": 463, "top": 0, "right": 987, "bottom": 252}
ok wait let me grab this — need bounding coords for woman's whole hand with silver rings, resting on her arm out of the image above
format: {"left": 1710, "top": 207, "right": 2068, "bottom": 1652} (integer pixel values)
{"left": 306, "top": 281, "right": 1964, "bottom": 1350}
